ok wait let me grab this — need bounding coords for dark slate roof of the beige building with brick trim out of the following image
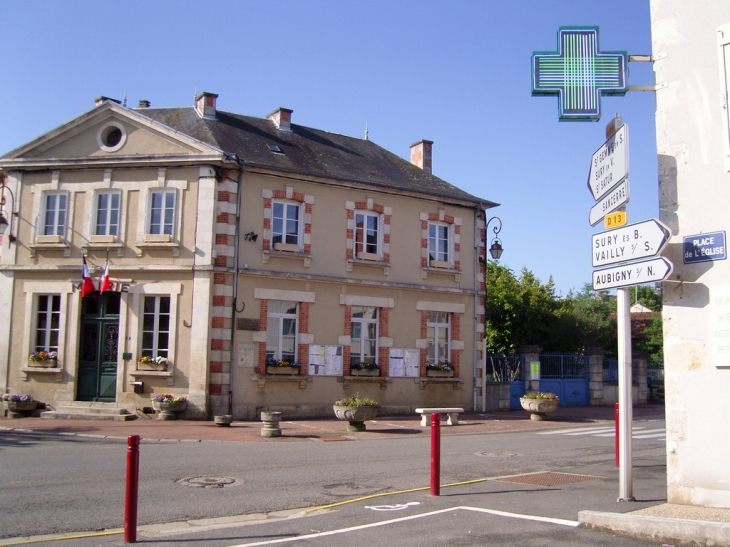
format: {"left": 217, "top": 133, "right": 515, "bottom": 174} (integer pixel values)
{"left": 132, "top": 106, "right": 497, "bottom": 207}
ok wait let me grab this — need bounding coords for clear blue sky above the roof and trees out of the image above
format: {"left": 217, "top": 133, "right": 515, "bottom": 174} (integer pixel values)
{"left": 0, "top": 0, "right": 658, "bottom": 295}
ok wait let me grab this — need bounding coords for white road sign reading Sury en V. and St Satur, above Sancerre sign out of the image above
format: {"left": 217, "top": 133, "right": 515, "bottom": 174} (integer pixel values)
{"left": 588, "top": 124, "right": 629, "bottom": 201}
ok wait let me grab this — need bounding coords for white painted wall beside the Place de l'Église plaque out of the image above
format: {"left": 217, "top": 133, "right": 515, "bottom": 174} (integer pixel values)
{"left": 651, "top": 0, "right": 730, "bottom": 507}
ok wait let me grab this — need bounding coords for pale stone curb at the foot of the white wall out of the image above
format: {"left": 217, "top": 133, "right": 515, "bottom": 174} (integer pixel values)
{"left": 578, "top": 511, "right": 730, "bottom": 547}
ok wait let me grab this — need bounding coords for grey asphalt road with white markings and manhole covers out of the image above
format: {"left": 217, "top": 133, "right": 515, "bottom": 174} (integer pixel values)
{"left": 0, "top": 421, "right": 666, "bottom": 547}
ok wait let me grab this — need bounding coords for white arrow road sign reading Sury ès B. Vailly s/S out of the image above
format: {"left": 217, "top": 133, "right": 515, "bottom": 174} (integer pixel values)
{"left": 591, "top": 218, "right": 669, "bottom": 267}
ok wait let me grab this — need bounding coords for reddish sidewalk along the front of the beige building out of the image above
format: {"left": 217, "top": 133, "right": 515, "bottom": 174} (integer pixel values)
{"left": 0, "top": 405, "right": 664, "bottom": 442}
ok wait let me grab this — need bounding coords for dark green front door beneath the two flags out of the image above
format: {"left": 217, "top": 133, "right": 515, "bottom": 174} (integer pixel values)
{"left": 76, "top": 291, "right": 121, "bottom": 403}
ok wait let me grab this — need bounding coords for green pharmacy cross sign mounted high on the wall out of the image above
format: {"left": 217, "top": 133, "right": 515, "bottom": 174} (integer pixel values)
{"left": 532, "top": 27, "right": 629, "bottom": 122}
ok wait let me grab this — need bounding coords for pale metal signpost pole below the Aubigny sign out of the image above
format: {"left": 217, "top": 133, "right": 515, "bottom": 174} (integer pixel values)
{"left": 616, "top": 287, "right": 635, "bottom": 501}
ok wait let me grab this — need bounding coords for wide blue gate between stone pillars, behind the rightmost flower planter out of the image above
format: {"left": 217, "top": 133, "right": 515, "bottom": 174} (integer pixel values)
{"left": 540, "top": 353, "right": 590, "bottom": 406}
